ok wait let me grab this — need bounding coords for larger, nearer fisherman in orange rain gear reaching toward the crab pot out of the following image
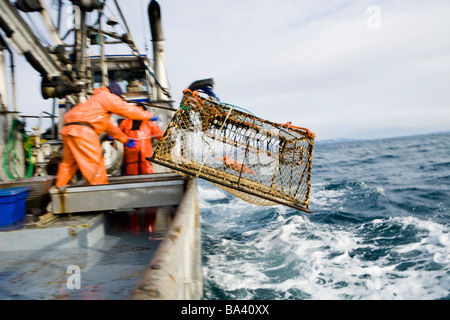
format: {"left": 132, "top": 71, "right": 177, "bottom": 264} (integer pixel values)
{"left": 56, "top": 87, "right": 153, "bottom": 189}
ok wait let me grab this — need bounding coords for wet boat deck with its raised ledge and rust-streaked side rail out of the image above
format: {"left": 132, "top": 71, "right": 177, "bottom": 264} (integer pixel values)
{"left": 0, "top": 173, "right": 203, "bottom": 300}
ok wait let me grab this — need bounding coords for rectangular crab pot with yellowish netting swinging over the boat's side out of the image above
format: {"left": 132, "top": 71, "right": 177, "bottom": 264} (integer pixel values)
{"left": 152, "top": 90, "right": 314, "bottom": 212}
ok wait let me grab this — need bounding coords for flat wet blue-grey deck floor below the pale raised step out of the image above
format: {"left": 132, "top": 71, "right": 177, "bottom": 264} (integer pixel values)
{"left": 0, "top": 212, "right": 163, "bottom": 300}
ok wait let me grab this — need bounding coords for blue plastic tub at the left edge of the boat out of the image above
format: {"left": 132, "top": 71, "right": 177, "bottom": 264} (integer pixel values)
{"left": 0, "top": 187, "right": 31, "bottom": 227}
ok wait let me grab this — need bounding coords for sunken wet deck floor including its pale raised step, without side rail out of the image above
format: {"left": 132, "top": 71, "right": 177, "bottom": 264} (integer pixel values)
{"left": 0, "top": 211, "right": 170, "bottom": 300}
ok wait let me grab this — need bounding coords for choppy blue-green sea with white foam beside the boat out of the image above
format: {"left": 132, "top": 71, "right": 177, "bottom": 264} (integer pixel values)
{"left": 197, "top": 133, "right": 450, "bottom": 300}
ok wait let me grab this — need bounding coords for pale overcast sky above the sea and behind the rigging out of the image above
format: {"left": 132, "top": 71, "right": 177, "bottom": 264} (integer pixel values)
{"left": 7, "top": 0, "right": 450, "bottom": 140}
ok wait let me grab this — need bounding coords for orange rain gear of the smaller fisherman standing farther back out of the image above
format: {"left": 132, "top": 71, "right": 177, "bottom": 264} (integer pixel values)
{"left": 119, "top": 119, "right": 164, "bottom": 175}
